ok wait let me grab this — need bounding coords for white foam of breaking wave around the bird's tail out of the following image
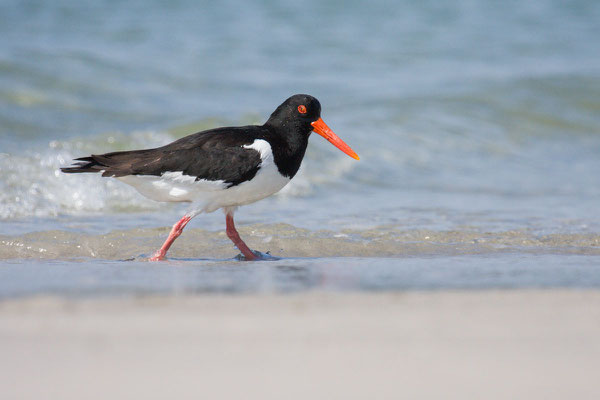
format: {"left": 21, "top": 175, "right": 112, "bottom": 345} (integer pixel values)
{"left": 0, "top": 132, "right": 175, "bottom": 219}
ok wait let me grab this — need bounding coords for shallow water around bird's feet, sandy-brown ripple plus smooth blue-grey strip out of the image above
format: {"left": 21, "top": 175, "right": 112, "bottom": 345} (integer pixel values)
{"left": 0, "top": 224, "right": 600, "bottom": 297}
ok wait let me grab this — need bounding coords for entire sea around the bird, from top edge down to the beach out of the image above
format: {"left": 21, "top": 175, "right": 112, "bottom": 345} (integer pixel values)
{"left": 0, "top": 0, "right": 600, "bottom": 295}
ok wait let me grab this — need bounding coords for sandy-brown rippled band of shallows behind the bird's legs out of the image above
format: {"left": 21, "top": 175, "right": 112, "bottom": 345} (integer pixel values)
{"left": 0, "top": 223, "right": 600, "bottom": 261}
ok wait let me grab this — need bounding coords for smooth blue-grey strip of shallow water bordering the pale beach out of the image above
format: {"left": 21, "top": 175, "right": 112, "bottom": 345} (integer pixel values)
{"left": 0, "top": 253, "right": 600, "bottom": 299}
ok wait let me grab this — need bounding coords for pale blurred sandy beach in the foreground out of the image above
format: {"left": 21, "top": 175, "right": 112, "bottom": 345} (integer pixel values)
{"left": 0, "top": 290, "right": 600, "bottom": 399}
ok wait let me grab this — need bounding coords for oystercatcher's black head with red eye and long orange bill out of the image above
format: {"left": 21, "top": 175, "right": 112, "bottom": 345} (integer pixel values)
{"left": 265, "top": 94, "right": 359, "bottom": 160}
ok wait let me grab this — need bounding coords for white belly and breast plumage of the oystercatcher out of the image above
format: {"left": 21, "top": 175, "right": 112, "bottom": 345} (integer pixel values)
{"left": 117, "top": 139, "right": 291, "bottom": 212}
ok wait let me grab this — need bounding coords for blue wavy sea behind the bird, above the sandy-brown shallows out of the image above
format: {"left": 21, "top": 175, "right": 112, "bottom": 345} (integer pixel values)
{"left": 0, "top": 0, "right": 600, "bottom": 294}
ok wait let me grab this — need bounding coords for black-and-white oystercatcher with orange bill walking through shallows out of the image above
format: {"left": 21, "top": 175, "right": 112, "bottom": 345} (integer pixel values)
{"left": 61, "top": 94, "right": 359, "bottom": 261}
